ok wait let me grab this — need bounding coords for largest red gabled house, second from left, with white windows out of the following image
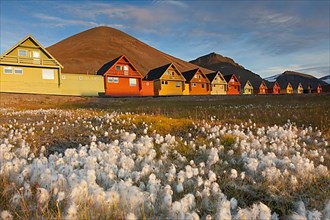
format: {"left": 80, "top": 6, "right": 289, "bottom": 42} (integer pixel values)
{"left": 97, "top": 55, "right": 142, "bottom": 96}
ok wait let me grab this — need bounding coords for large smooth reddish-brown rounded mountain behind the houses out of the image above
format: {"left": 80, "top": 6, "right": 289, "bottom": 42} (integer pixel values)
{"left": 47, "top": 26, "right": 211, "bottom": 75}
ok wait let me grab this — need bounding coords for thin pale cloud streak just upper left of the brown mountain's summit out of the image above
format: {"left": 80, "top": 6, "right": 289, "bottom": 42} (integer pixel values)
{"left": 34, "top": 13, "right": 99, "bottom": 27}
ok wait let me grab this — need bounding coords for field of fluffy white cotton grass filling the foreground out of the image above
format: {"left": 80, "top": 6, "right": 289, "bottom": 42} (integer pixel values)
{"left": 0, "top": 103, "right": 330, "bottom": 220}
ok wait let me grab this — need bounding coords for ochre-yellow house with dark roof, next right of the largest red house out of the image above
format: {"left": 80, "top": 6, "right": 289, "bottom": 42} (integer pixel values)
{"left": 143, "top": 63, "right": 185, "bottom": 96}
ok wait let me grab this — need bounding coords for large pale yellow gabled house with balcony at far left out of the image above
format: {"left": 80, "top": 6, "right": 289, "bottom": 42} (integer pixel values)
{"left": 0, "top": 35, "right": 63, "bottom": 94}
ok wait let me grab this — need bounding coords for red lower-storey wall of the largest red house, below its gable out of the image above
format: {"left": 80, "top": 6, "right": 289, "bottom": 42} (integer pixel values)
{"left": 104, "top": 75, "right": 142, "bottom": 96}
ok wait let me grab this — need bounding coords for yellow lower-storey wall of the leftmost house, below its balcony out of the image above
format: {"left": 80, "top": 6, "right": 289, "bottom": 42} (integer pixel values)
{"left": 0, "top": 64, "right": 61, "bottom": 95}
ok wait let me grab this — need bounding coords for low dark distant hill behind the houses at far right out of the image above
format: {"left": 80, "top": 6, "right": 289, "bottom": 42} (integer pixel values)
{"left": 265, "top": 71, "right": 327, "bottom": 88}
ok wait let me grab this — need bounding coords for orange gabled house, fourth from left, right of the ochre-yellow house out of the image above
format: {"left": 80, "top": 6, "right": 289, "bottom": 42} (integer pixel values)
{"left": 182, "top": 68, "right": 211, "bottom": 95}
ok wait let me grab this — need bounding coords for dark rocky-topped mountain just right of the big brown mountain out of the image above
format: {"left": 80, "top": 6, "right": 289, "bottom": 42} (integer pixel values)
{"left": 189, "top": 52, "right": 262, "bottom": 87}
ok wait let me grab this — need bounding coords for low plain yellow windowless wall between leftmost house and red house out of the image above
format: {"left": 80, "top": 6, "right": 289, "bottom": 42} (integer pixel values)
{"left": 60, "top": 73, "right": 104, "bottom": 96}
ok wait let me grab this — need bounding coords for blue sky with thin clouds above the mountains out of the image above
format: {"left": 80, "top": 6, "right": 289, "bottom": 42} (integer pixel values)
{"left": 0, "top": 0, "right": 330, "bottom": 78}
